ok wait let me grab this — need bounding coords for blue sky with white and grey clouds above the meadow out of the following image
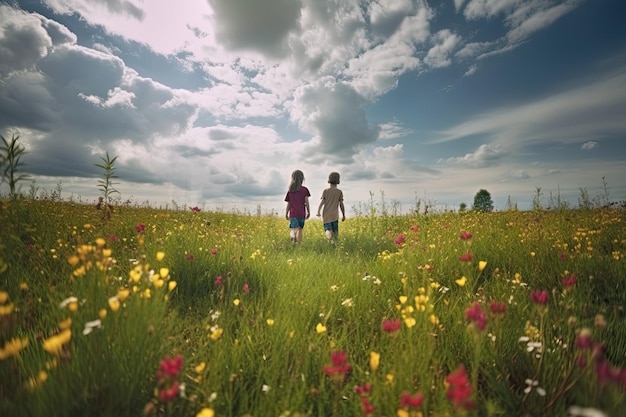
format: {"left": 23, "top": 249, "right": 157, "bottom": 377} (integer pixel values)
{"left": 0, "top": 0, "right": 626, "bottom": 215}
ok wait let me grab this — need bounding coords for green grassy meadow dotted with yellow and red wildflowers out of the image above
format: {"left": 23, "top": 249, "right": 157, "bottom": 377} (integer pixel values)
{"left": 0, "top": 199, "right": 626, "bottom": 417}
